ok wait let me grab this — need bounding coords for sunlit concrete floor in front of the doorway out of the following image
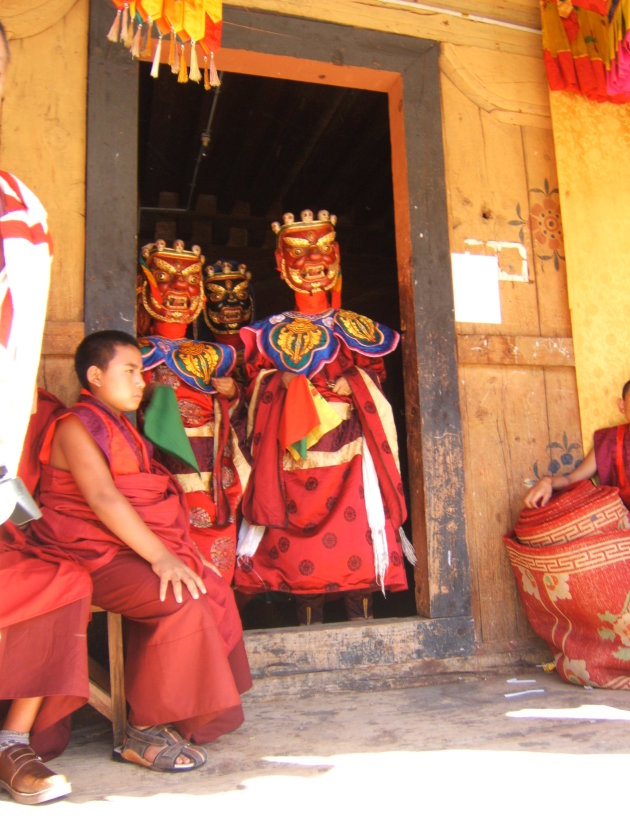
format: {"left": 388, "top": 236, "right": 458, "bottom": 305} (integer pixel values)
{"left": 0, "top": 667, "right": 630, "bottom": 840}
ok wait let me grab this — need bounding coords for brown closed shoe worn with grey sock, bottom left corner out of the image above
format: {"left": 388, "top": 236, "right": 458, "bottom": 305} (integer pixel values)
{"left": 0, "top": 744, "right": 72, "bottom": 805}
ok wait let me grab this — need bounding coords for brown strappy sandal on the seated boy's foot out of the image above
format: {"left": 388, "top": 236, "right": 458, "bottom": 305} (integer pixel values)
{"left": 112, "top": 723, "right": 208, "bottom": 773}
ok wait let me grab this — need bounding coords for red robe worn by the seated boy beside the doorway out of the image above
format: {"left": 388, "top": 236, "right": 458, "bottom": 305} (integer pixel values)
{"left": 30, "top": 391, "right": 251, "bottom": 743}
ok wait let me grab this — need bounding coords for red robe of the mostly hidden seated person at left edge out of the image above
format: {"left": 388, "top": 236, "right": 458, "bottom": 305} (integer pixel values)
{"left": 0, "top": 391, "right": 92, "bottom": 758}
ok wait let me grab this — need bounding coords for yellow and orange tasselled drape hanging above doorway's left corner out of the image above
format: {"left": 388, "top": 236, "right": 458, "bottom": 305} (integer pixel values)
{"left": 107, "top": 0, "right": 223, "bottom": 90}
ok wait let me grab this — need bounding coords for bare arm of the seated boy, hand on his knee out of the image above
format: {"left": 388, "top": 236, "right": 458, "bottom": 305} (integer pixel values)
{"left": 50, "top": 416, "right": 206, "bottom": 603}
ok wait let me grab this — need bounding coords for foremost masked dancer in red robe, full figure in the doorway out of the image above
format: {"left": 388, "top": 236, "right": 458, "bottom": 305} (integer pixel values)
{"left": 234, "top": 210, "right": 418, "bottom": 624}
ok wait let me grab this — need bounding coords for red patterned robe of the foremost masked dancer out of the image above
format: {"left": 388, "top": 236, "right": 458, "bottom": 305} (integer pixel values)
{"left": 234, "top": 310, "right": 407, "bottom": 595}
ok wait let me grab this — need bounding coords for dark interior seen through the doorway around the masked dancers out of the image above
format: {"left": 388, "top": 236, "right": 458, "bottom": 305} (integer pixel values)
{"left": 138, "top": 63, "right": 415, "bottom": 627}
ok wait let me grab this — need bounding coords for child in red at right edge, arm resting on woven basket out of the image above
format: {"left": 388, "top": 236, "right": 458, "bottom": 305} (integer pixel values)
{"left": 524, "top": 380, "right": 630, "bottom": 508}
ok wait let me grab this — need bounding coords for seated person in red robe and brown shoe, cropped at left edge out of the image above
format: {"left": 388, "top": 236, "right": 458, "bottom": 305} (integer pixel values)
{"left": 0, "top": 391, "right": 92, "bottom": 805}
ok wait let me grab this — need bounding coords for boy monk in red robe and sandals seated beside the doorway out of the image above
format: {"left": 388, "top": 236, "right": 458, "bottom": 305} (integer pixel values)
{"left": 30, "top": 330, "right": 251, "bottom": 771}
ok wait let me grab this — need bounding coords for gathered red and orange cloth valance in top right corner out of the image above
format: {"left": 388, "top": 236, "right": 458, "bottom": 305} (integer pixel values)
{"left": 540, "top": 0, "right": 630, "bottom": 102}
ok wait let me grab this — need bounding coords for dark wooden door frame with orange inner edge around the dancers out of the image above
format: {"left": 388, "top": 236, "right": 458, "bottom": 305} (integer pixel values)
{"left": 85, "top": 3, "right": 472, "bottom": 644}
